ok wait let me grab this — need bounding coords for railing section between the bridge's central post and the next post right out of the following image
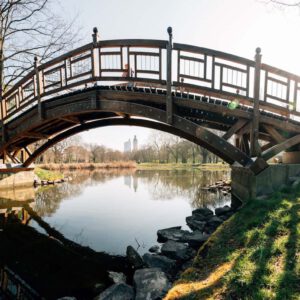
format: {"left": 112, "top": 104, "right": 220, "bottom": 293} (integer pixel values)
{"left": 173, "top": 43, "right": 255, "bottom": 99}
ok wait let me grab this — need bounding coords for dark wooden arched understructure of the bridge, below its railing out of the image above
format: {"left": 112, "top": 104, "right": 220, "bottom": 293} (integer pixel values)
{"left": 0, "top": 86, "right": 300, "bottom": 174}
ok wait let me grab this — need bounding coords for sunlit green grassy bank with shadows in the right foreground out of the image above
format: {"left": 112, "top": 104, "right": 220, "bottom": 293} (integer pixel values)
{"left": 165, "top": 188, "right": 300, "bottom": 300}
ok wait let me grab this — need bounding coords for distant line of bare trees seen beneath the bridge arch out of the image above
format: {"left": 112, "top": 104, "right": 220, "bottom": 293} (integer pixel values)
{"left": 31, "top": 131, "right": 220, "bottom": 164}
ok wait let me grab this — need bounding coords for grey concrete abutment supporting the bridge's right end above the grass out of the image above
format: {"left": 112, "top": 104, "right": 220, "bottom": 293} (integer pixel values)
{"left": 231, "top": 164, "right": 300, "bottom": 202}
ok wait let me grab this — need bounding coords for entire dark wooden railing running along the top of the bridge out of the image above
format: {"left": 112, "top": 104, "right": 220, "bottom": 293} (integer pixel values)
{"left": 1, "top": 33, "right": 300, "bottom": 123}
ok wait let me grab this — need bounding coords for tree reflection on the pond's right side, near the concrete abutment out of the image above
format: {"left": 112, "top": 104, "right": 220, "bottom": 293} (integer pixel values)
{"left": 135, "top": 170, "right": 230, "bottom": 207}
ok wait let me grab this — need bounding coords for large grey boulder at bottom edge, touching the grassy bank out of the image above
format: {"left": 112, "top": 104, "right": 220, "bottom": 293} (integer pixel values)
{"left": 133, "top": 268, "right": 171, "bottom": 300}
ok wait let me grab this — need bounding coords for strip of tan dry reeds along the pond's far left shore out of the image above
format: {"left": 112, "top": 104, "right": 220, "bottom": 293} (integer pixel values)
{"left": 38, "top": 161, "right": 136, "bottom": 171}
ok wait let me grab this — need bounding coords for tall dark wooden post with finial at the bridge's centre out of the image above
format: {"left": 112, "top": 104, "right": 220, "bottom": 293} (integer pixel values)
{"left": 166, "top": 27, "right": 173, "bottom": 124}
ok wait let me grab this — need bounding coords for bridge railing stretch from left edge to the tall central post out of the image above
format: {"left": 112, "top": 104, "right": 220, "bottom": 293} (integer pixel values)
{"left": 1, "top": 40, "right": 167, "bottom": 121}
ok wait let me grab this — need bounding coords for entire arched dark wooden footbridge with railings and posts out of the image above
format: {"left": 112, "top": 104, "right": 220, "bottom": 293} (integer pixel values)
{"left": 0, "top": 28, "right": 300, "bottom": 173}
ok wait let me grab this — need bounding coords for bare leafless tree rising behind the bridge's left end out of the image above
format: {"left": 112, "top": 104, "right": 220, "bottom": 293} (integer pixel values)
{"left": 0, "top": 0, "right": 78, "bottom": 96}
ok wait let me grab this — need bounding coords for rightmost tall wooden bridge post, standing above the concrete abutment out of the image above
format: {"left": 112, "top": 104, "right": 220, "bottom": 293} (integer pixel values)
{"left": 250, "top": 48, "right": 261, "bottom": 157}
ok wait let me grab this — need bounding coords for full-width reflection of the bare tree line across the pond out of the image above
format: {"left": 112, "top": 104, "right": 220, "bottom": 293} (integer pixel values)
{"left": 35, "top": 169, "right": 230, "bottom": 216}
